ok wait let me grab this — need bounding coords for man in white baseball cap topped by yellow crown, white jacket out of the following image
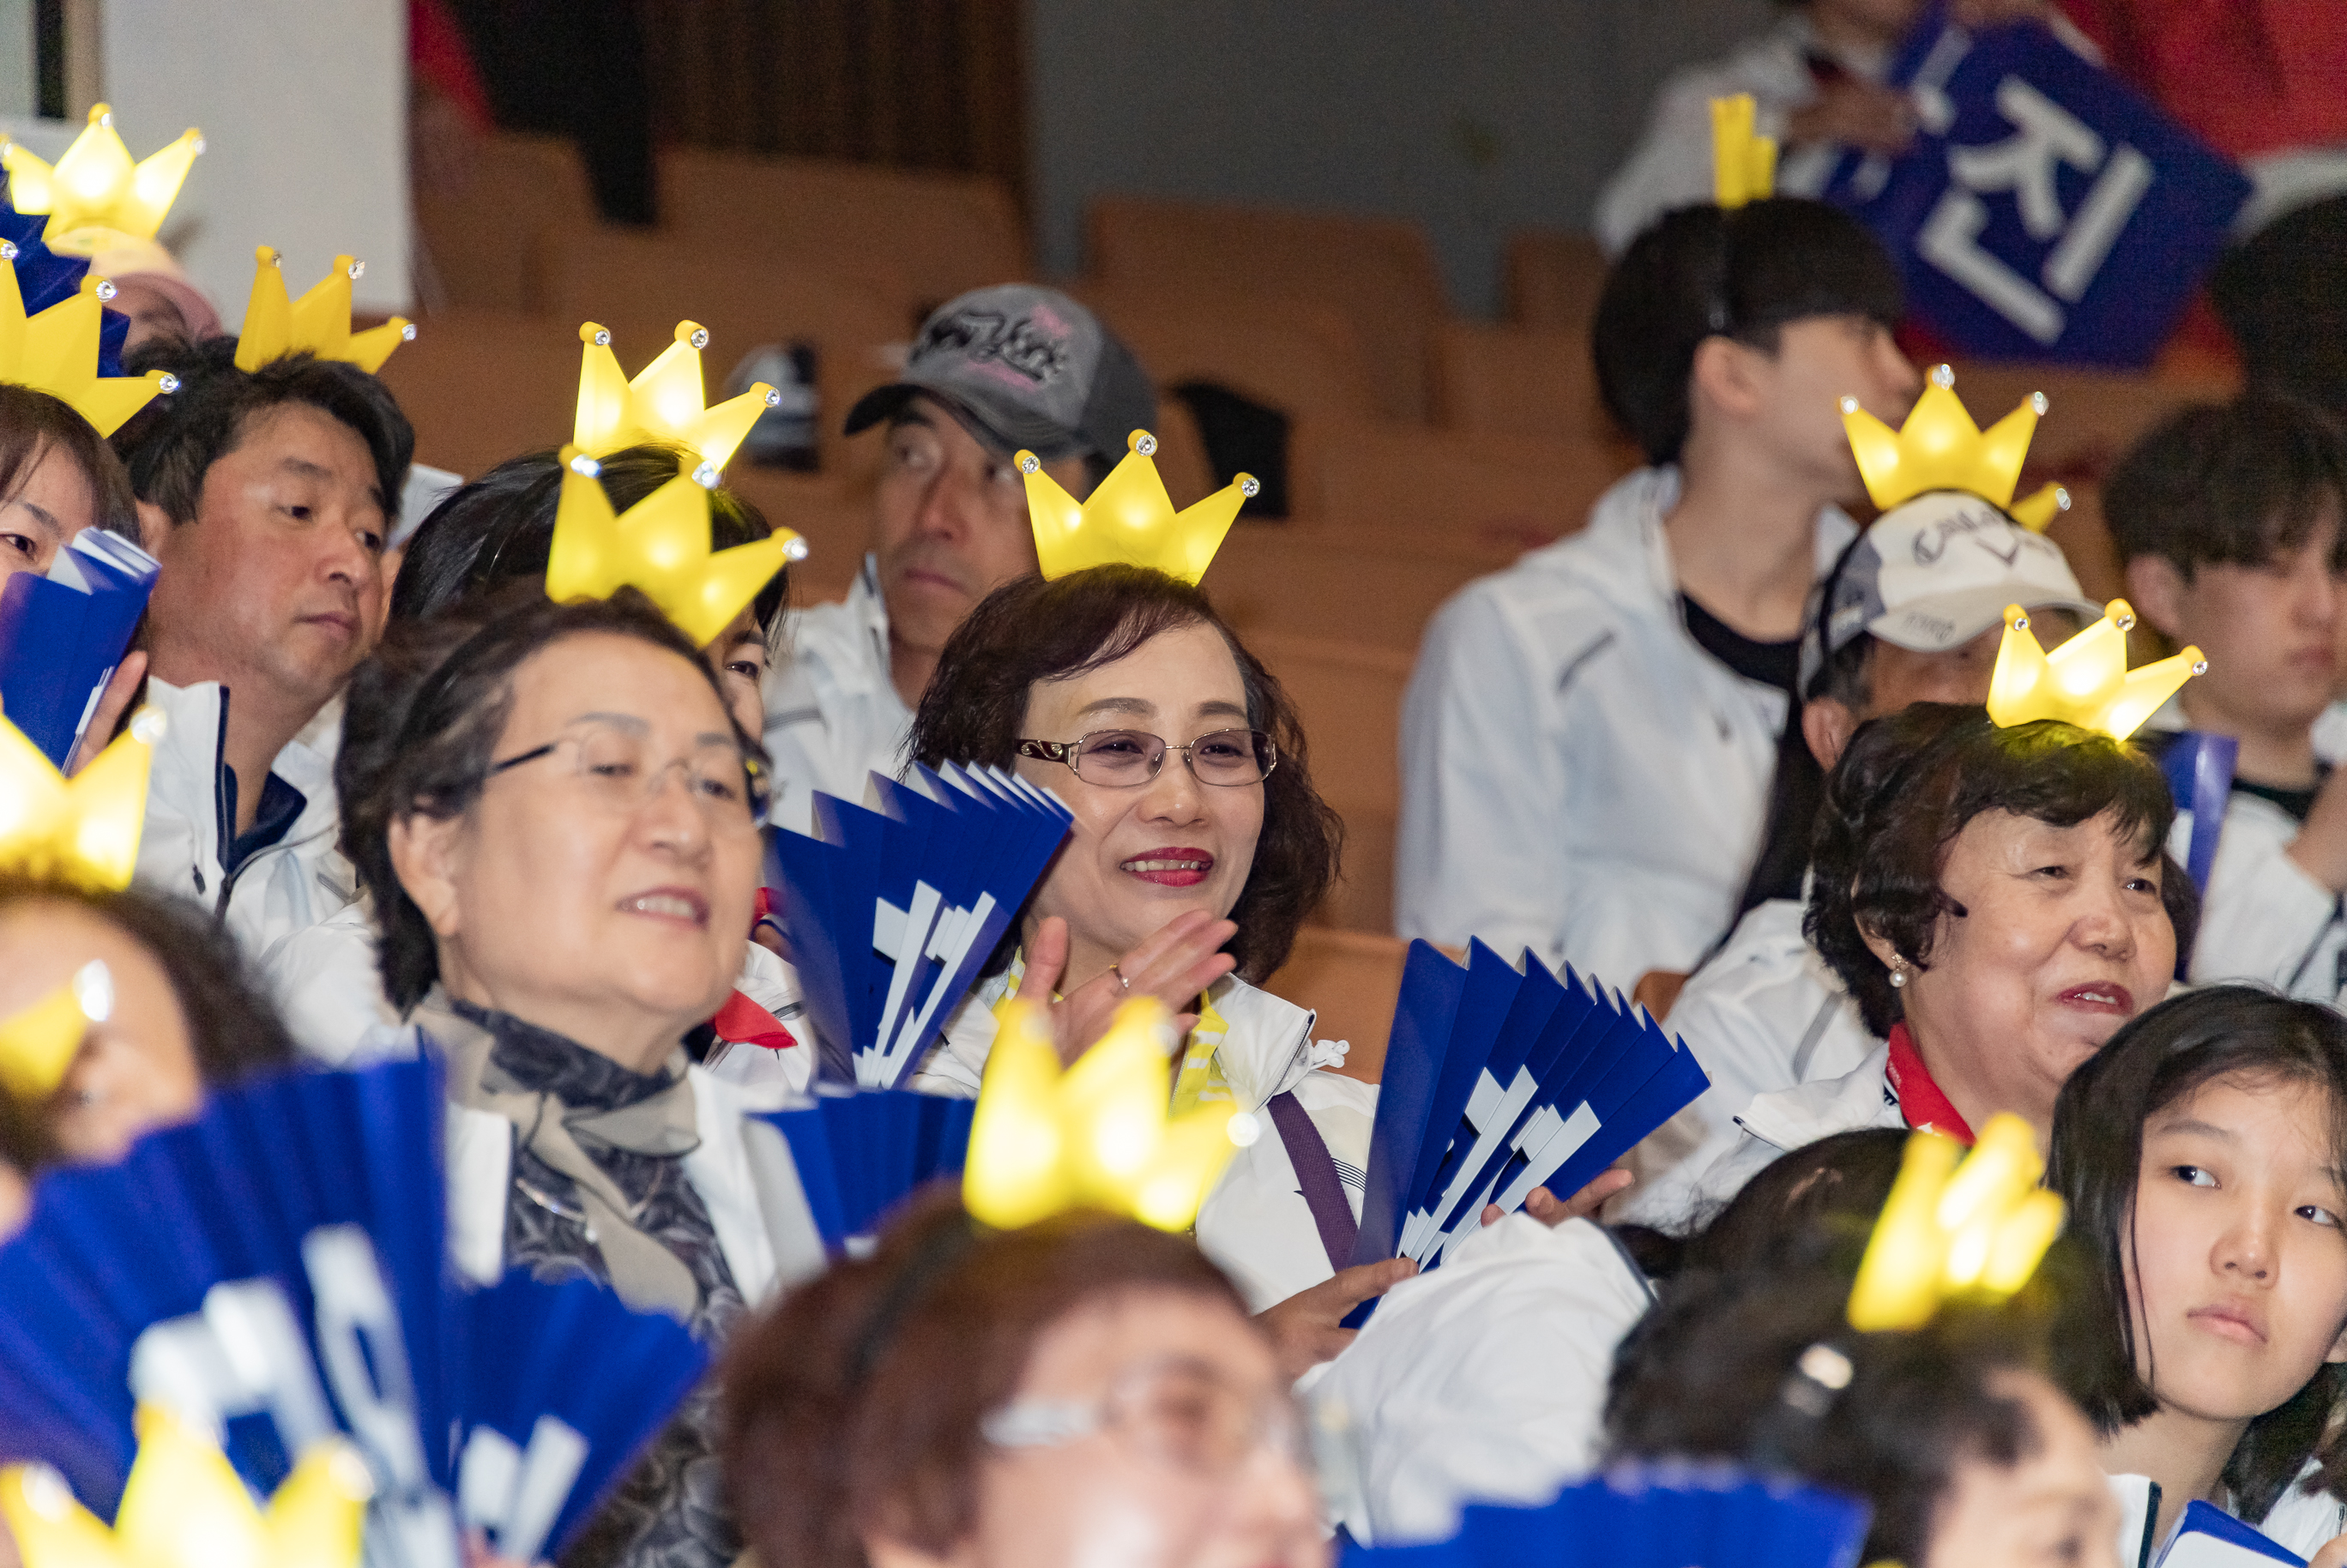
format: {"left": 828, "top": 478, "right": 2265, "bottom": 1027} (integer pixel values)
{"left": 1620, "top": 491, "right": 2103, "bottom": 1225}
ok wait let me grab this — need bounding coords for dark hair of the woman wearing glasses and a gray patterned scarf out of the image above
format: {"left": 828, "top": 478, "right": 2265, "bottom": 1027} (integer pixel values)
{"left": 334, "top": 582, "right": 765, "bottom": 1014}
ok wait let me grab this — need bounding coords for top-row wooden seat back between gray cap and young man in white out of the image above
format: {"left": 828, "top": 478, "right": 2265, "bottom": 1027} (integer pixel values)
{"left": 1089, "top": 197, "right": 1448, "bottom": 420}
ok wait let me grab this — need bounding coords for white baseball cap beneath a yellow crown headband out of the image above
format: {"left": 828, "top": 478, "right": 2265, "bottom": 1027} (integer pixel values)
{"left": 1801, "top": 491, "right": 2103, "bottom": 691}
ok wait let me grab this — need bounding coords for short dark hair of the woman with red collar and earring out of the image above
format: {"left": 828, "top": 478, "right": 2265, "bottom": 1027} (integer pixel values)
{"left": 1801, "top": 702, "right": 2199, "bottom": 1035}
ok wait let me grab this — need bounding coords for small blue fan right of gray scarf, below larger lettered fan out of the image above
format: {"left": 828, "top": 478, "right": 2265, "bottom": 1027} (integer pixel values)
{"left": 751, "top": 1089, "right": 976, "bottom": 1256}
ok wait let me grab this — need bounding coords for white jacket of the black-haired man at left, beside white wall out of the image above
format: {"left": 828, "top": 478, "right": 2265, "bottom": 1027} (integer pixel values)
{"left": 136, "top": 678, "right": 359, "bottom": 960}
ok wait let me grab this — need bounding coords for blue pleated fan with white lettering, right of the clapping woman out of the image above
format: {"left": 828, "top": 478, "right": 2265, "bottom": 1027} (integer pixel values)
{"left": 1355, "top": 941, "right": 1711, "bottom": 1268}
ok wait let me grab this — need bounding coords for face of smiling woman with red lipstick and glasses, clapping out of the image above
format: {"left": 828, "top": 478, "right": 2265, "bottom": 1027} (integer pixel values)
{"left": 1018, "top": 624, "right": 1263, "bottom": 988}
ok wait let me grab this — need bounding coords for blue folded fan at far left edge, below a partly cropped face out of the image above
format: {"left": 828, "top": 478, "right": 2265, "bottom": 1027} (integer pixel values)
{"left": 0, "top": 528, "right": 160, "bottom": 768}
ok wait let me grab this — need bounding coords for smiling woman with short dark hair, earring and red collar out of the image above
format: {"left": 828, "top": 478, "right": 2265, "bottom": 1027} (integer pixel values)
{"left": 1699, "top": 702, "right": 2197, "bottom": 1202}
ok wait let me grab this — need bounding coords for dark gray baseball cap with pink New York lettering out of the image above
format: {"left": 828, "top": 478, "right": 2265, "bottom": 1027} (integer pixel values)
{"left": 848, "top": 284, "right": 1157, "bottom": 462}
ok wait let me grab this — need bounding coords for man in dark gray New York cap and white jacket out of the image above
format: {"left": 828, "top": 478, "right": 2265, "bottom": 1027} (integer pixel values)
{"left": 765, "top": 284, "right": 1157, "bottom": 831}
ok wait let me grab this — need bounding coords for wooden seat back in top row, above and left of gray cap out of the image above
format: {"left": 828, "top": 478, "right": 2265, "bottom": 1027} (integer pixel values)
{"left": 660, "top": 148, "right": 1035, "bottom": 326}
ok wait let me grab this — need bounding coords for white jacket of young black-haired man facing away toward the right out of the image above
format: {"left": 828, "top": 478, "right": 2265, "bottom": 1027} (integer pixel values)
{"left": 1394, "top": 467, "right": 1856, "bottom": 991}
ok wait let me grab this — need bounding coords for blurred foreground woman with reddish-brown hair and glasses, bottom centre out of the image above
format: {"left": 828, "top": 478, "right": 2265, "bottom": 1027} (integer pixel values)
{"left": 725, "top": 1197, "right": 1329, "bottom": 1568}
